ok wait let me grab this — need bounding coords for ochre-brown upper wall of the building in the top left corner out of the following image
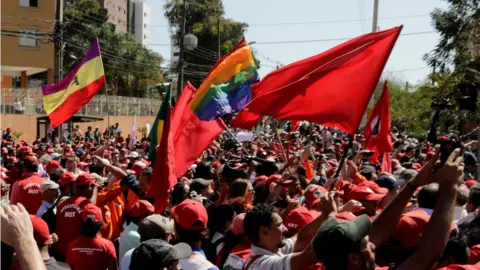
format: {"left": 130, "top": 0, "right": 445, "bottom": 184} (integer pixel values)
{"left": 1, "top": 0, "right": 55, "bottom": 69}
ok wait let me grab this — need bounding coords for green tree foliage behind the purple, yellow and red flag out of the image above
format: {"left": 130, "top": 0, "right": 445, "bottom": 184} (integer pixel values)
{"left": 63, "top": 0, "right": 164, "bottom": 97}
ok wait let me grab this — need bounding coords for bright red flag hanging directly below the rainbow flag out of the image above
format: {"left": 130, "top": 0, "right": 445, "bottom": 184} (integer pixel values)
{"left": 172, "top": 83, "right": 226, "bottom": 178}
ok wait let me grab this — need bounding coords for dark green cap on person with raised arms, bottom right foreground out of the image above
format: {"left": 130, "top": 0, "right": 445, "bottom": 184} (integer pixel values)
{"left": 312, "top": 215, "right": 372, "bottom": 269}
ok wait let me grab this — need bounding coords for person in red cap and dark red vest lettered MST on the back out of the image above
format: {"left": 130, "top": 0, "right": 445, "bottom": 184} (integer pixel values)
{"left": 56, "top": 173, "right": 97, "bottom": 260}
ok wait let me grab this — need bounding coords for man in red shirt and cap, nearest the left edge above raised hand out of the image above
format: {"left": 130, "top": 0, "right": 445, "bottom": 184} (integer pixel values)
{"left": 10, "top": 156, "right": 45, "bottom": 215}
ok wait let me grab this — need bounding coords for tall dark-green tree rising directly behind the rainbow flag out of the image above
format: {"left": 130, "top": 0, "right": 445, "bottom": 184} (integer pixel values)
{"left": 164, "top": 0, "right": 248, "bottom": 86}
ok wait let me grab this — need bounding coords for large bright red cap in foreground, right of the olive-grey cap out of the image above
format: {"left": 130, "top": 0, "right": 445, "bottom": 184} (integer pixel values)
{"left": 170, "top": 199, "right": 208, "bottom": 230}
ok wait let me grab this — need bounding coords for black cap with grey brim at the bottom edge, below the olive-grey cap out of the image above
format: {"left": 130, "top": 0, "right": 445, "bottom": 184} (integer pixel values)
{"left": 130, "top": 239, "right": 192, "bottom": 270}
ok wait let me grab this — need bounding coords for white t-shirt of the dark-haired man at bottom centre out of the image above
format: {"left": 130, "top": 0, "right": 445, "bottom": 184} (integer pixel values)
{"left": 245, "top": 239, "right": 295, "bottom": 270}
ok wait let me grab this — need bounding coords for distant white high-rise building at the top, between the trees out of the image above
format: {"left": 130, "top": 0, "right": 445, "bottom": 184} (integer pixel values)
{"left": 128, "top": 0, "right": 152, "bottom": 45}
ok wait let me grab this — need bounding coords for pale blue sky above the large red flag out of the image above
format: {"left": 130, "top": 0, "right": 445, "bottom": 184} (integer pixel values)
{"left": 142, "top": 0, "right": 446, "bottom": 83}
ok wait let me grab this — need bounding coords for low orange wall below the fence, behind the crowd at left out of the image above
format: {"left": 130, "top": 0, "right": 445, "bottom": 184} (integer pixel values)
{"left": 0, "top": 114, "right": 155, "bottom": 142}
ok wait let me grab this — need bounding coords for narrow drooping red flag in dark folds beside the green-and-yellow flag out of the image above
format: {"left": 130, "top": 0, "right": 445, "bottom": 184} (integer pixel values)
{"left": 147, "top": 87, "right": 177, "bottom": 214}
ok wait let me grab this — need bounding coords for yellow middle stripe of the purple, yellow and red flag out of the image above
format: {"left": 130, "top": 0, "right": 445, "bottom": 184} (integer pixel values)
{"left": 43, "top": 56, "right": 105, "bottom": 114}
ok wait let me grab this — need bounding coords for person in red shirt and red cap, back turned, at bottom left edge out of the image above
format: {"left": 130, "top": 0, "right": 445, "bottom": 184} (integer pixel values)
{"left": 67, "top": 203, "right": 118, "bottom": 270}
